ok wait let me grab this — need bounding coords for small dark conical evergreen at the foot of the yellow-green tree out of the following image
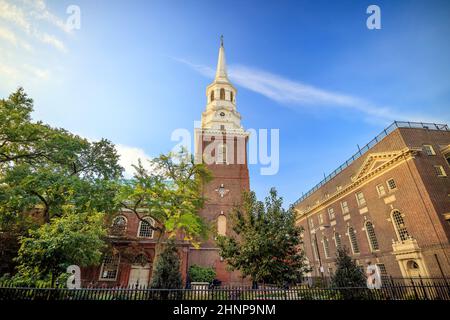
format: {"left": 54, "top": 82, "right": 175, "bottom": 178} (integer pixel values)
{"left": 151, "top": 240, "right": 182, "bottom": 289}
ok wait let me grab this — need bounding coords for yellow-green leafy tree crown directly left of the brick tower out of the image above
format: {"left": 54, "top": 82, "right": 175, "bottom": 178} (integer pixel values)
{"left": 117, "top": 150, "right": 211, "bottom": 245}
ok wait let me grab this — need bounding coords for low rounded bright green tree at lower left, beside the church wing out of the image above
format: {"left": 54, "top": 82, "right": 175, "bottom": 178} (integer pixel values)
{"left": 17, "top": 212, "right": 106, "bottom": 287}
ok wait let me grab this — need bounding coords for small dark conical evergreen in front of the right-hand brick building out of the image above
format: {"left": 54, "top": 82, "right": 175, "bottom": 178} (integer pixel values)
{"left": 331, "top": 248, "right": 366, "bottom": 299}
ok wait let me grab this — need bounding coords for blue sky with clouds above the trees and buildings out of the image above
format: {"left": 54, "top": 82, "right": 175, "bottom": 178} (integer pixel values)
{"left": 0, "top": 0, "right": 450, "bottom": 203}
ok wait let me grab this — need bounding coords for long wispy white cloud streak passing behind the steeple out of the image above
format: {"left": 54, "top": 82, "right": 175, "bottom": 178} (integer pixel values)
{"left": 174, "top": 58, "right": 436, "bottom": 122}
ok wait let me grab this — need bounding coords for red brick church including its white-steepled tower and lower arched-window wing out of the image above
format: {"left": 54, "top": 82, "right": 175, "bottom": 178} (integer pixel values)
{"left": 82, "top": 41, "right": 250, "bottom": 287}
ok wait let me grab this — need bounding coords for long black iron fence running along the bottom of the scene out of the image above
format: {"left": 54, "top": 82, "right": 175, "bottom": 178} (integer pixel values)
{"left": 0, "top": 278, "right": 450, "bottom": 301}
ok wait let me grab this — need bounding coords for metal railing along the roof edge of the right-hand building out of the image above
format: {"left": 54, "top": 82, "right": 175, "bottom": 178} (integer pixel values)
{"left": 293, "top": 121, "right": 449, "bottom": 206}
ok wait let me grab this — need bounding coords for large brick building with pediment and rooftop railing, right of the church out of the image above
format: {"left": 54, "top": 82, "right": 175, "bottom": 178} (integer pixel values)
{"left": 294, "top": 122, "right": 450, "bottom": 277}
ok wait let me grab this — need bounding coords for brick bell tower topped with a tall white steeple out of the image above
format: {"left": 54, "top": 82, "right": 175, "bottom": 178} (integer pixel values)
{"left": 189, "top": 37, "right": 250, "bottom": 284}
